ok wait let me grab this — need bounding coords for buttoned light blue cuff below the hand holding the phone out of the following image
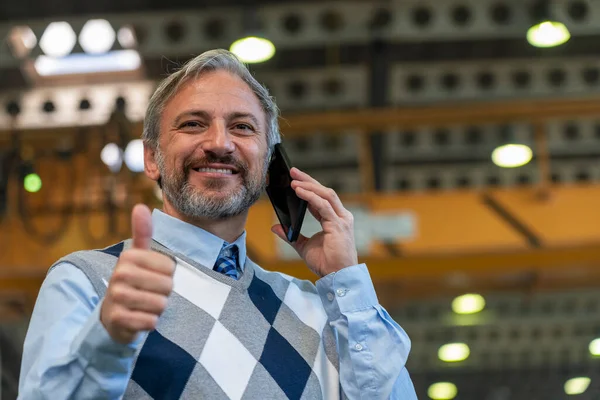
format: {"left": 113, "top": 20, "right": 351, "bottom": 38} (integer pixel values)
{"left": 316, "top": 264, "right": 379, "bottom": 320}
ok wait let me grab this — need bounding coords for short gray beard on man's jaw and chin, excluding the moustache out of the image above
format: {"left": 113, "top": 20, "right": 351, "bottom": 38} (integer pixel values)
{"left": 156, "top": 150, "right": 268, "bottom": 220}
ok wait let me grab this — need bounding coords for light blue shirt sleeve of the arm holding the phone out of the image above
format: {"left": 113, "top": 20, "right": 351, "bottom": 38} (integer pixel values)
{"left": 316, "top": 264, "right": 417, "bottom": 400}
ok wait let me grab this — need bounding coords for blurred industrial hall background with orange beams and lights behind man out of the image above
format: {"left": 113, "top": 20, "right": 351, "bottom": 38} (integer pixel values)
{"left": 0, "top": 0, "right": 600, "bottom": 400}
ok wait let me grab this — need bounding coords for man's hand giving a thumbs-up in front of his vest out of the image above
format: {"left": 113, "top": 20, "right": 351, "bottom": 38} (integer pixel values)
{"left": 100, "top": 204, "right": 175, "bottom": 344}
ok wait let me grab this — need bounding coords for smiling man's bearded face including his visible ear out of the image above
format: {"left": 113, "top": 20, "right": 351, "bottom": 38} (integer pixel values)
{"left": 146, "top": 71, "right": 267, "bottom": 219}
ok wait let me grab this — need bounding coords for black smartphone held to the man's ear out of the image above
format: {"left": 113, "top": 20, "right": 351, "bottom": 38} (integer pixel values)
{"left": 267, "top": 143, "right": 308, "bottom": 242}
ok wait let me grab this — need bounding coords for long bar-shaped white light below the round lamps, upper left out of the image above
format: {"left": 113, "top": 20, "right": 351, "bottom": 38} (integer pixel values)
{"left": 34, "top": 50, "right": 142, "bottom": 76}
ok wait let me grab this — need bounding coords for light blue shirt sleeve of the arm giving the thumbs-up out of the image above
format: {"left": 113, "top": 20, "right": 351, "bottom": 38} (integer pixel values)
{"left": 19, "top": 263, "right": 141, "bottom": 400}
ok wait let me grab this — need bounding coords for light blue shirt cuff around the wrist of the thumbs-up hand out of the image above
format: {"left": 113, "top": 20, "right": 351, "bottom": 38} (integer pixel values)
{"left": 72, "top": 301, "right": 145, "bottom": 369}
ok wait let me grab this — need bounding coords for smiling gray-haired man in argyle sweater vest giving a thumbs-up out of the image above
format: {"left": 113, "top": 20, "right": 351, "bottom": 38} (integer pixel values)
{"left": 19, "top": 50, "right": 416, "bottom": 400}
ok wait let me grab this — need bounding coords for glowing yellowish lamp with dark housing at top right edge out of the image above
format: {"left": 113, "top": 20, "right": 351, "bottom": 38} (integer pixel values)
{"left": 527, "top": 0, "right": 571, "bottom": 48}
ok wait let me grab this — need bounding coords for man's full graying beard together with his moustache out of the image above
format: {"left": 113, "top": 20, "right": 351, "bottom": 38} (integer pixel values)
{"left": 156, "top": 149, "right": 268, "bottom": 220}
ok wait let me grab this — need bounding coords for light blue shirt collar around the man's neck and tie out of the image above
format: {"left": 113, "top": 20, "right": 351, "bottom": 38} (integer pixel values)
{"left": 152, "top": 209, "right": 246, "bottom": 271}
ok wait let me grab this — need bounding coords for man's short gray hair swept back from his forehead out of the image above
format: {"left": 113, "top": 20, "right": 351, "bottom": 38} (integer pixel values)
{"left": 142, "top": 49, "right": 281, "bottom": 157}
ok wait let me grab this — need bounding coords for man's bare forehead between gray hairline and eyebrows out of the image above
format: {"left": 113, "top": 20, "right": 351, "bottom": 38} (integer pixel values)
{"left": 163, "top": 71, "right": 266, "bottom": 126}
